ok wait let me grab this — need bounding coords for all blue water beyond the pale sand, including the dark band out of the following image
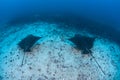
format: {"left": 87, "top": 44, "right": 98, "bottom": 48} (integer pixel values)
{"left": 0, "top": 0, "right": 120, "bottom": 80}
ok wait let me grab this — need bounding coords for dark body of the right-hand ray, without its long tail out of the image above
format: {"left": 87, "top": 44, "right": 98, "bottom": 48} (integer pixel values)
{"left": 69, "top": 34, "right": 95, "bottom": 54}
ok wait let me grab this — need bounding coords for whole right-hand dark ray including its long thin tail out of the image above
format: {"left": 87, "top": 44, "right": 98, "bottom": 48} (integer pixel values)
{"left": 69, "top": 34, "right": 105, "bottom": 75}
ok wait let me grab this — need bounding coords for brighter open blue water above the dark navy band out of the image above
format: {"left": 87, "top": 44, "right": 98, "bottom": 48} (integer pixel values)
{"left": 0, "top": 0, "right": 120, "bottom": 26}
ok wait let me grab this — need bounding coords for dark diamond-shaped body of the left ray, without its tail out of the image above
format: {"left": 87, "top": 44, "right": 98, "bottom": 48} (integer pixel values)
{"left": 18, "top": 34, "right": 41, "bottom": 52}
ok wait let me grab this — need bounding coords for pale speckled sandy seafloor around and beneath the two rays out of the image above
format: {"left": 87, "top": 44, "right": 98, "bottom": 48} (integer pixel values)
{"left": 0, "top": 23, "right": 120, "bottom": 80}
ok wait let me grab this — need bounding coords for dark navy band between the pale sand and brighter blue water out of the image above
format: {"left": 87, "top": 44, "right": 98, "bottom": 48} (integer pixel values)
{"left": 8, "top": 13, "right": 120, "bottom": 45}
